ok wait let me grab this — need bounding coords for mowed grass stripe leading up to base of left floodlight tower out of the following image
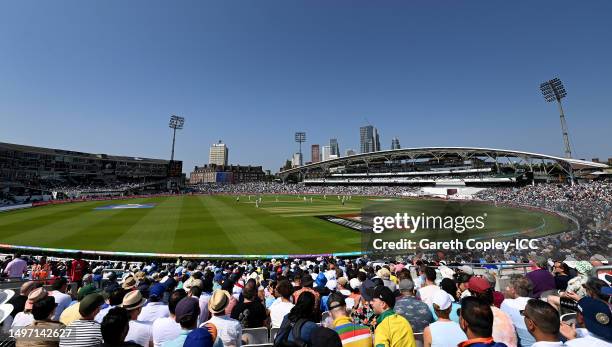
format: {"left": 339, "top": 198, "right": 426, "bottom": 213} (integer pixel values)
{"left": 109, "top": 196, "right": 185, "bottom": 252}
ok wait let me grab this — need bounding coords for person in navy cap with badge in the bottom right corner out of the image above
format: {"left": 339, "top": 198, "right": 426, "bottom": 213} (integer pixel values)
{"left": 561, "top": 297, "right": 612, "bottom": 347}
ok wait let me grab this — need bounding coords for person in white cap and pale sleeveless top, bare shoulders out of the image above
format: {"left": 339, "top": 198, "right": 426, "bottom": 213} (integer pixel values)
{"left": 423, "top": 290, "right": 467, "bottom": 347}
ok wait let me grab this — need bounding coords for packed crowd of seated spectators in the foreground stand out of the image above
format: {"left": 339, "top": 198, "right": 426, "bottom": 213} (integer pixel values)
{"left": 2, "top": 254, "right": 612, "bottom": 347}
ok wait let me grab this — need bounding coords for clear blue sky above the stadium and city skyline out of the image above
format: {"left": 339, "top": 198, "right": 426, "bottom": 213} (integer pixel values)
{"left": 0, "top": 0, "right": 612, "bottom": 172}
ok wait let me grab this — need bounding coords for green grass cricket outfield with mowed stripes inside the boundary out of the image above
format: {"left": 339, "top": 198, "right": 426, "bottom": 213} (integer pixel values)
{"left": 0, "top": 195, "right": 569, "bottom": 255}
